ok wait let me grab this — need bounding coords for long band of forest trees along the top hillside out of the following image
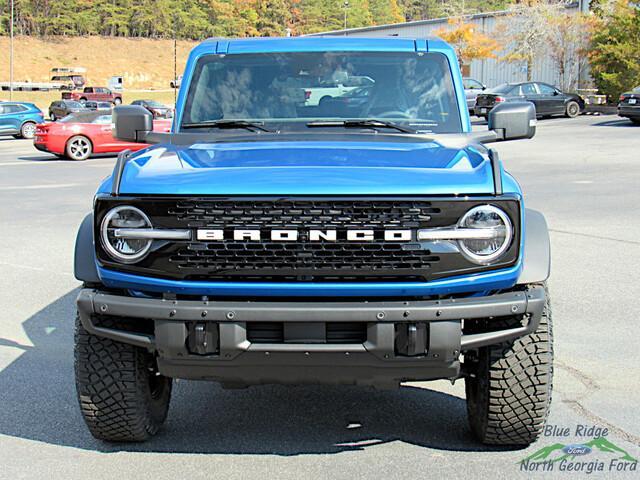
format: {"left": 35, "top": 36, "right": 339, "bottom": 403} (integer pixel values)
{"left": 0, "top": 0, "right": 524, "bottom": 40}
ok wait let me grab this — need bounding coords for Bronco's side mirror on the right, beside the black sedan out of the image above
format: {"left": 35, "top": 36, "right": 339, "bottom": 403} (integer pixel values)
{"left": 489, "top": 102, "right": 536, "bottom": 140}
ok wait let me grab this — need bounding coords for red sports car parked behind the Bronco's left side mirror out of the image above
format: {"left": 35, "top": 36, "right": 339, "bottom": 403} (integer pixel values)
{"left": 34, "top": 111, "right": 171, "bottom": 160}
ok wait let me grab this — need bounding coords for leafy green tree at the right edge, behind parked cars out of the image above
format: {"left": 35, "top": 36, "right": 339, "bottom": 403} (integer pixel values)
{"left": 590, "top": 0, "right": 640, "bottom": 100}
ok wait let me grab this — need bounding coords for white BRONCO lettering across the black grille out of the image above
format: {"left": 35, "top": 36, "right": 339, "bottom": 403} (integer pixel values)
{"left": 196, "top": 229, "right": 412, "bottom": 242}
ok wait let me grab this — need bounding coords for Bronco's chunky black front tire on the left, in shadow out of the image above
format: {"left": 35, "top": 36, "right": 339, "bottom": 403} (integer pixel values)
{"left": 75, "top": 318, "right": 171, "bottom": 442}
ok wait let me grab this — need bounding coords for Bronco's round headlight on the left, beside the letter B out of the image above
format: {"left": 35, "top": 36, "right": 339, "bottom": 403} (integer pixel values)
{"left": 100, "top": 205, "right": 152, "bottom": 263}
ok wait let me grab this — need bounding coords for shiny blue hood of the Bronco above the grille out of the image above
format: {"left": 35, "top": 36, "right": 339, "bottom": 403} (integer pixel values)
{"left": 112, "top": 141, "right": 494, "bottom": 195}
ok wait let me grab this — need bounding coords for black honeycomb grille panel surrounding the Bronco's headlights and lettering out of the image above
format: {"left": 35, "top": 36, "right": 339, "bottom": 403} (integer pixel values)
{"left": 96, "top": 197, "right": 519, "bottom": 282}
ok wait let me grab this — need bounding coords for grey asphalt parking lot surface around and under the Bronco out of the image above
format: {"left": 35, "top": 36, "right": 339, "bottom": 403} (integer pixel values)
{"left": 0, "top": 116, "right": 640, "bottom": 479}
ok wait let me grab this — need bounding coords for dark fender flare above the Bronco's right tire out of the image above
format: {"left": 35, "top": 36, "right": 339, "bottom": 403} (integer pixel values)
{"left": 517, "top": 208, "right": 551, "bottom": 285}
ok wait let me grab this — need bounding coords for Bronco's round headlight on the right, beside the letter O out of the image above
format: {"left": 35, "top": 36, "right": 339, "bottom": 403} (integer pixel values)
{"left": 458, "top": 205, "right": 513, "bottom": 264}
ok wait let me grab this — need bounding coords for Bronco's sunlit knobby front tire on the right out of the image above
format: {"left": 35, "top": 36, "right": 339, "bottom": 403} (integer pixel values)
{"left": 465, "top": 284, "right": 553, "bottom": 446}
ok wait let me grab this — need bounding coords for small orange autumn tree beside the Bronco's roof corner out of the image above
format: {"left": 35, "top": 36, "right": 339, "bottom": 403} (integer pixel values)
{"left": 436, "top": 18, "right": 500, "bottom": 65}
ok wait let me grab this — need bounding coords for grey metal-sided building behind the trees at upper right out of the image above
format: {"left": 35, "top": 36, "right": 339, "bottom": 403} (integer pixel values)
{"left": 318, "top": 0, "right": 589, "bottom": 90}
